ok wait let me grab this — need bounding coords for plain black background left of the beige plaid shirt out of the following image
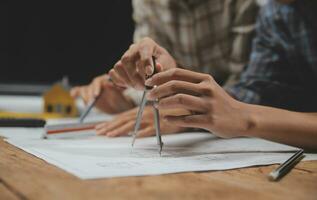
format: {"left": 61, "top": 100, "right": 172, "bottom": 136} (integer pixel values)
{"left": 0, "top": 0, "right": 133, "bottom": 84}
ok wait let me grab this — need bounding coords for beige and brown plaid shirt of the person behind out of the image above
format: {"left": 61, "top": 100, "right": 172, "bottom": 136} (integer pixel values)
{"left": 133, "top": 0, "right": 258, "bottom": 84}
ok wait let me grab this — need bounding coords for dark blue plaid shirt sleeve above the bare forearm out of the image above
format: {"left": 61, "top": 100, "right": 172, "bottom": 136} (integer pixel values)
{"left": 225, "top": 1, "right": 316, "bottom": 111}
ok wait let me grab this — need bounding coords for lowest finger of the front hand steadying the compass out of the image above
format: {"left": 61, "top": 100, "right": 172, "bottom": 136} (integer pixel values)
{"left": 164, "top": 115, "right": 207, "bottom": 128}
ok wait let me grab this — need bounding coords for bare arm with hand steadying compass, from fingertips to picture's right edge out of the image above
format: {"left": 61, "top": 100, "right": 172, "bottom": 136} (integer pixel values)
{"left": 146, "top": 68, "right": 317, "bottom": 149}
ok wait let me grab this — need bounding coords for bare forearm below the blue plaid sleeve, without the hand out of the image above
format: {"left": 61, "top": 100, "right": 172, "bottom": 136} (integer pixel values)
{"left": 242, "top": 104, "right": 317, "bottom": 150}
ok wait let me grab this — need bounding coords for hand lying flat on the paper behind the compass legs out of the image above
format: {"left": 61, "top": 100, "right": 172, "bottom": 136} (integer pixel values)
{"left": 96, "top": 106, "right": 186, "bottom": 137}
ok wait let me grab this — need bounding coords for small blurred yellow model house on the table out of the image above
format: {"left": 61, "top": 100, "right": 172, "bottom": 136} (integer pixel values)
{"left": 43, "top": 83, "right": 78, "bottom": 117}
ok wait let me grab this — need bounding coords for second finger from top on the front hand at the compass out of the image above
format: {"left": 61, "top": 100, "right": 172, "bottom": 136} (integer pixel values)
{"left": 147, "top": 80, "right": 202, "bottom": 100}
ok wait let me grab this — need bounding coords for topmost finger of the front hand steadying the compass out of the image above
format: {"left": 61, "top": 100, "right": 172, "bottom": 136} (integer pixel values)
{"left": 145, "top": 68, "right": 208, "bottom": 86}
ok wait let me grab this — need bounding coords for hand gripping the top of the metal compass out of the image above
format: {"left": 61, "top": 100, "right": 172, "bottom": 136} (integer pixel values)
{"left": 109, "top": 38, "right": 177, "bottom": 89}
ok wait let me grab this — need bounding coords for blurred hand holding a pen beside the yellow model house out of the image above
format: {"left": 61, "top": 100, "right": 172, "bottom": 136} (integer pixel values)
{"left": 70, "top": 74, "right": 134, "bottom": 114}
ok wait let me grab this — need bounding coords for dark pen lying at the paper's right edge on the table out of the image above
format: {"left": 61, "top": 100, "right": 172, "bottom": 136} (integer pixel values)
{"left": 268, "top": 149, "right": 304, "bottom": 181}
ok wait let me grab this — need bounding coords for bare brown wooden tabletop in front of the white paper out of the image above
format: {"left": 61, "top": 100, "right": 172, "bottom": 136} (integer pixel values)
{"left": 0, "top": 138, "right": 317, "bottom": 200}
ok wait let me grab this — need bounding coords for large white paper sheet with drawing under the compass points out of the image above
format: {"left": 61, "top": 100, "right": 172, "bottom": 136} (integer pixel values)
{"left": 7, "top": 133, "right": 317, "bottom": 179}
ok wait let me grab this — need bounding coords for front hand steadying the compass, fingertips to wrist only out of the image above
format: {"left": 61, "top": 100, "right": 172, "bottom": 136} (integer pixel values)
{"left": 146, "top": 68, "right": 250, "bottom": 137}
